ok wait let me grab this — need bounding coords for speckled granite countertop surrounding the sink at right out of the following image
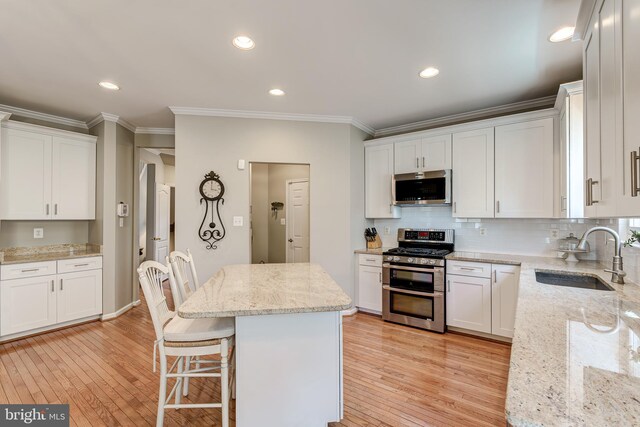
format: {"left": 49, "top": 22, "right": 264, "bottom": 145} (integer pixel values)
{"left": 448, "top": 252, "right": 640, "bottom": 426}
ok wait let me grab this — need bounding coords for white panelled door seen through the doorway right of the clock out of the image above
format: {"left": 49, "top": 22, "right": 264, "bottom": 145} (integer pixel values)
{"left": 286, "top": 180, "right": 309, "bottom": 262}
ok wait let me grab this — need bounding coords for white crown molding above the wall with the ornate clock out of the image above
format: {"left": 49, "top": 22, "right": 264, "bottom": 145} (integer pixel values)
{"left": 169, "top": 107, "right": 375, "bottom": 135}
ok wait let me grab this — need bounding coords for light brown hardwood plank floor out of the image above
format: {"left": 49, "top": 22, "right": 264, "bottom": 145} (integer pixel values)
{"left": 0, "top": 288, "right": 510, "bottom": 427}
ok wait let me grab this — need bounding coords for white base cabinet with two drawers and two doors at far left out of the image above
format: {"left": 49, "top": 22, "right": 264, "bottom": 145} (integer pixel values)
{"left": 0, "top": 257, "right": 102, "bottom": 339}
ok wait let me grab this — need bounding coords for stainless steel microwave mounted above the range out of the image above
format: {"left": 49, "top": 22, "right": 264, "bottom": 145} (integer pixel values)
{"left": 391, "top": 169, "right": 451, "bottom": 206}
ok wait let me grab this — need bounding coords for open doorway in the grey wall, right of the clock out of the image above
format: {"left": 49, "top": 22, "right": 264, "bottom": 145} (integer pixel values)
{"left": 249, "top": 162, "right": 310, "bottom": 264}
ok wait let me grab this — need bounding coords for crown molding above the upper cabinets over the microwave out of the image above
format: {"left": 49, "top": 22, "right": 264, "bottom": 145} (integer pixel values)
{"left": 374, "top": 95, "right": 556, "bottom": 138}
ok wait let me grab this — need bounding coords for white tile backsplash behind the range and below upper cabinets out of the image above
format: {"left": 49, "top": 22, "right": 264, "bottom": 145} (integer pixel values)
{"left": 374, "top": 207, "right": 598, "bottom": 259}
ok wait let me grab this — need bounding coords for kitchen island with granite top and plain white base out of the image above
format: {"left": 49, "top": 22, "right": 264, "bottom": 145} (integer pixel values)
{"left": 178, "top": 264, "right": 351, "bottom": 427}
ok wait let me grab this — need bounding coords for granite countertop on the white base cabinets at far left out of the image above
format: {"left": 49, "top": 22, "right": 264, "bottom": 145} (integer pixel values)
{"left": 0, "top": 243, "right": 102, "bottom": 264}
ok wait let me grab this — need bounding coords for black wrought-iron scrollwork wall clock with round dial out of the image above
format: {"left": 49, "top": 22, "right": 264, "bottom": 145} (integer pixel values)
{"left": 198, "top": 171, "right": 226, "bottom": 249}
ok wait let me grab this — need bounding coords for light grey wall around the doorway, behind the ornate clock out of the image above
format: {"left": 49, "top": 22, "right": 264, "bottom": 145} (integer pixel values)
{"left": 175, "top": 115, "right": 364, "bottom": 295}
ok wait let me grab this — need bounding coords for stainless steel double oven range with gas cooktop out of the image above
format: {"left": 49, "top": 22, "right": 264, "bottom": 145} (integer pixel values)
{"left": 382, "top": 228, "right": 454, "bottom": 333}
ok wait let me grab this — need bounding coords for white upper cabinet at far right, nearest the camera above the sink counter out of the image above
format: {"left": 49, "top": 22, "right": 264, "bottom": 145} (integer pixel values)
{"left": 576, "top": 0, "right": 640, "bottom": 218}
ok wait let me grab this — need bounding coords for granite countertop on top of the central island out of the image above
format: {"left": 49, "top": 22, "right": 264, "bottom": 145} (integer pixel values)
{"left": 178, "top": 264, "right": 351, "bottom": 319}
